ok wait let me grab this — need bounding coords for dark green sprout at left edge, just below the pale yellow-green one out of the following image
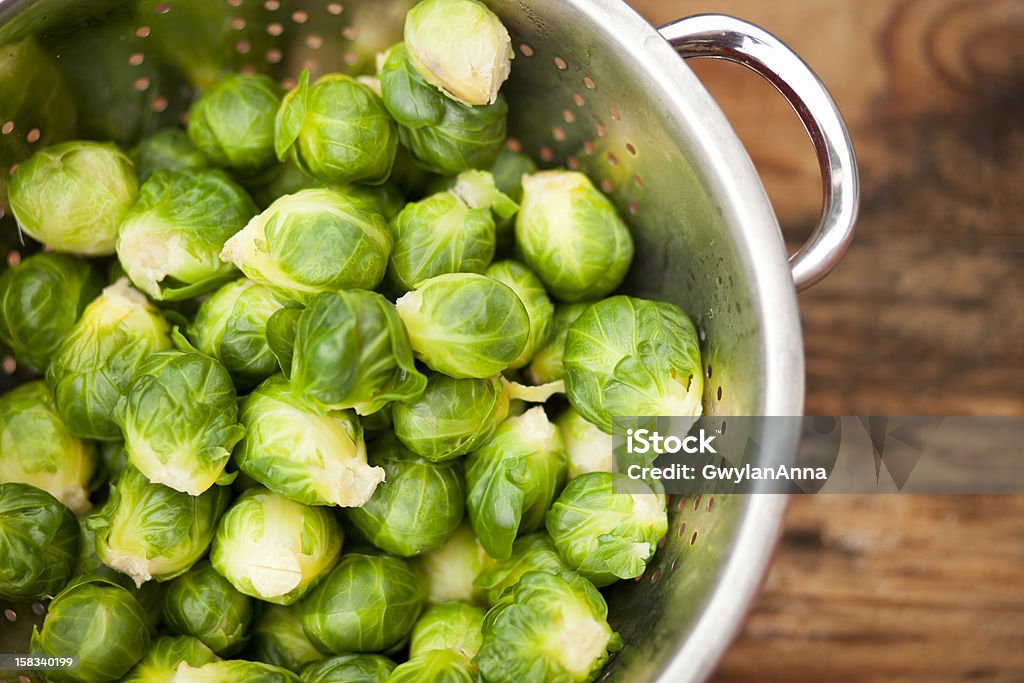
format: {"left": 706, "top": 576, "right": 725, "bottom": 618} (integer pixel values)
{"left": 0, "top": 253, "right": 103, "bottom": 372}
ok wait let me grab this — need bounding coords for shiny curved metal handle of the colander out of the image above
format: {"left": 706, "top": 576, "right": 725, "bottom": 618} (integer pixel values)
{"left": 659, "top": 14, "right": 860, "bottom": 290}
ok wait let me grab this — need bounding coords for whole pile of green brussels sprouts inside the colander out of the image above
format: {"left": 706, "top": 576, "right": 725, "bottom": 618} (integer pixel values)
{"left": 0, "top": 0, "right": 702, "bottom": 683}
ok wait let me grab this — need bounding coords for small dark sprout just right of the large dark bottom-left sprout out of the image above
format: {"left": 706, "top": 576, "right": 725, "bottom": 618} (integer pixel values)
{"left": 162, "top": 561, "right": 253, "bottom": 655}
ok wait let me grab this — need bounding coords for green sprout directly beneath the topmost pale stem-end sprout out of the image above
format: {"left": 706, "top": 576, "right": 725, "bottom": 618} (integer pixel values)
{"left": 380, "top": 43, "right": 509, "bottom": 175}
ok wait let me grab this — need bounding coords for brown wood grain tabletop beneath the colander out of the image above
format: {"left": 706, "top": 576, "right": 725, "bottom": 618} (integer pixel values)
{"left": 632, "top": 0, "right": 1024, "bottom": 683}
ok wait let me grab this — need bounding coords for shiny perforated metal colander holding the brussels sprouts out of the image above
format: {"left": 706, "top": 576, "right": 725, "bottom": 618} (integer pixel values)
{"left": 0, "top": 0, "right": 857, "bottom": 683}
